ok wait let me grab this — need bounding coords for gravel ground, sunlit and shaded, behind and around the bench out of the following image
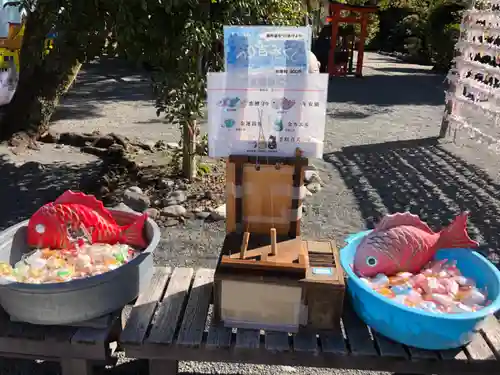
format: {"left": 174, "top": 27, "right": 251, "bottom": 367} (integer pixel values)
{"left": 0, "top": 53, "right": 500, "bottom": 375}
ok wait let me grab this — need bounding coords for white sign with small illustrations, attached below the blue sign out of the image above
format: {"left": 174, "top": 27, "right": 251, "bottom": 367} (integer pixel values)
{"left": 207, "top": 73, "right": 328, "bottom": 158}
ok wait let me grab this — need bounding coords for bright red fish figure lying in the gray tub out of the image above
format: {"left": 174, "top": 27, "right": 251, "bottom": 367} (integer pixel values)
{"left": 27, "top": 190, "right": 147, "bottom": 249}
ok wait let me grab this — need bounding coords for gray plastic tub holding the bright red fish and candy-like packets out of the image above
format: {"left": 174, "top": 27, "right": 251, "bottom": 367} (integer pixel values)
{"left": 0, "top": 209, "right": 160, "bottom": 325}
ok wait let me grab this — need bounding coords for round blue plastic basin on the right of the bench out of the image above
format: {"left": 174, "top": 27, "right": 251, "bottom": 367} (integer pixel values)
{"left": 340, "top": 231, "right": 500, "bottom": 350}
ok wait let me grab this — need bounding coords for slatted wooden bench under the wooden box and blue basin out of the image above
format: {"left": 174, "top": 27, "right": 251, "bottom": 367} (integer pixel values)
{"left": 120, "top": 267, "right": 500, "bottom": 375}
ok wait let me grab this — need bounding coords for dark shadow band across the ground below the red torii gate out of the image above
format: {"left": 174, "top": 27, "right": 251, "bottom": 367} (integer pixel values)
{"left": 328, "top": 73, "right": 445, "bottom": 107}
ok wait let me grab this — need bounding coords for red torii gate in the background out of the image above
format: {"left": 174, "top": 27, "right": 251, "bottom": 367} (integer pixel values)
{"left": 328, "top": 1, "right": 378, "bottom": 77}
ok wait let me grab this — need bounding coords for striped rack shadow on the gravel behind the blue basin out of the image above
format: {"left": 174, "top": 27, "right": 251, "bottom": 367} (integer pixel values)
{"left": 324, "top": 138, "right": 500, "bottom": 265}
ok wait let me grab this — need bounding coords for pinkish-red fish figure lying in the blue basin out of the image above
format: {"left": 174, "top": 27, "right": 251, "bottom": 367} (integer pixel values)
{"left": 354, "top": 212, "right": 478, "bottom": 277}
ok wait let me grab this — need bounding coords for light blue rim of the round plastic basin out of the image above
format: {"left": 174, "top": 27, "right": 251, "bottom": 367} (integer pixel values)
{"left": 340, "top": 230, "right": 500, "bottom": 321}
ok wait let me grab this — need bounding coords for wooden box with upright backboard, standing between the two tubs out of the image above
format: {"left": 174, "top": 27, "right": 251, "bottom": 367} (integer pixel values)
{"left": 214, "top": 156, "right": 344, "bottom": 332}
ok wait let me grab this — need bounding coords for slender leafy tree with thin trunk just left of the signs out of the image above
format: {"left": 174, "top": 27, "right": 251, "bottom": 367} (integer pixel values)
{"left": 116, "top": 0, "right": 304, "bottom": 182}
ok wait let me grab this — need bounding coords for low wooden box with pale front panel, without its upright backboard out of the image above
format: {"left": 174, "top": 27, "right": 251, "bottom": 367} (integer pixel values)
{"left": 214, "top": 237, "right": 345, "bottom": 332}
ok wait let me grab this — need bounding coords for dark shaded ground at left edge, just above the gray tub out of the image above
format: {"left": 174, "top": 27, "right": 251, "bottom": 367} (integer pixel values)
{"left": 0, "top": 155, "right": 102, "bottom": 230}
